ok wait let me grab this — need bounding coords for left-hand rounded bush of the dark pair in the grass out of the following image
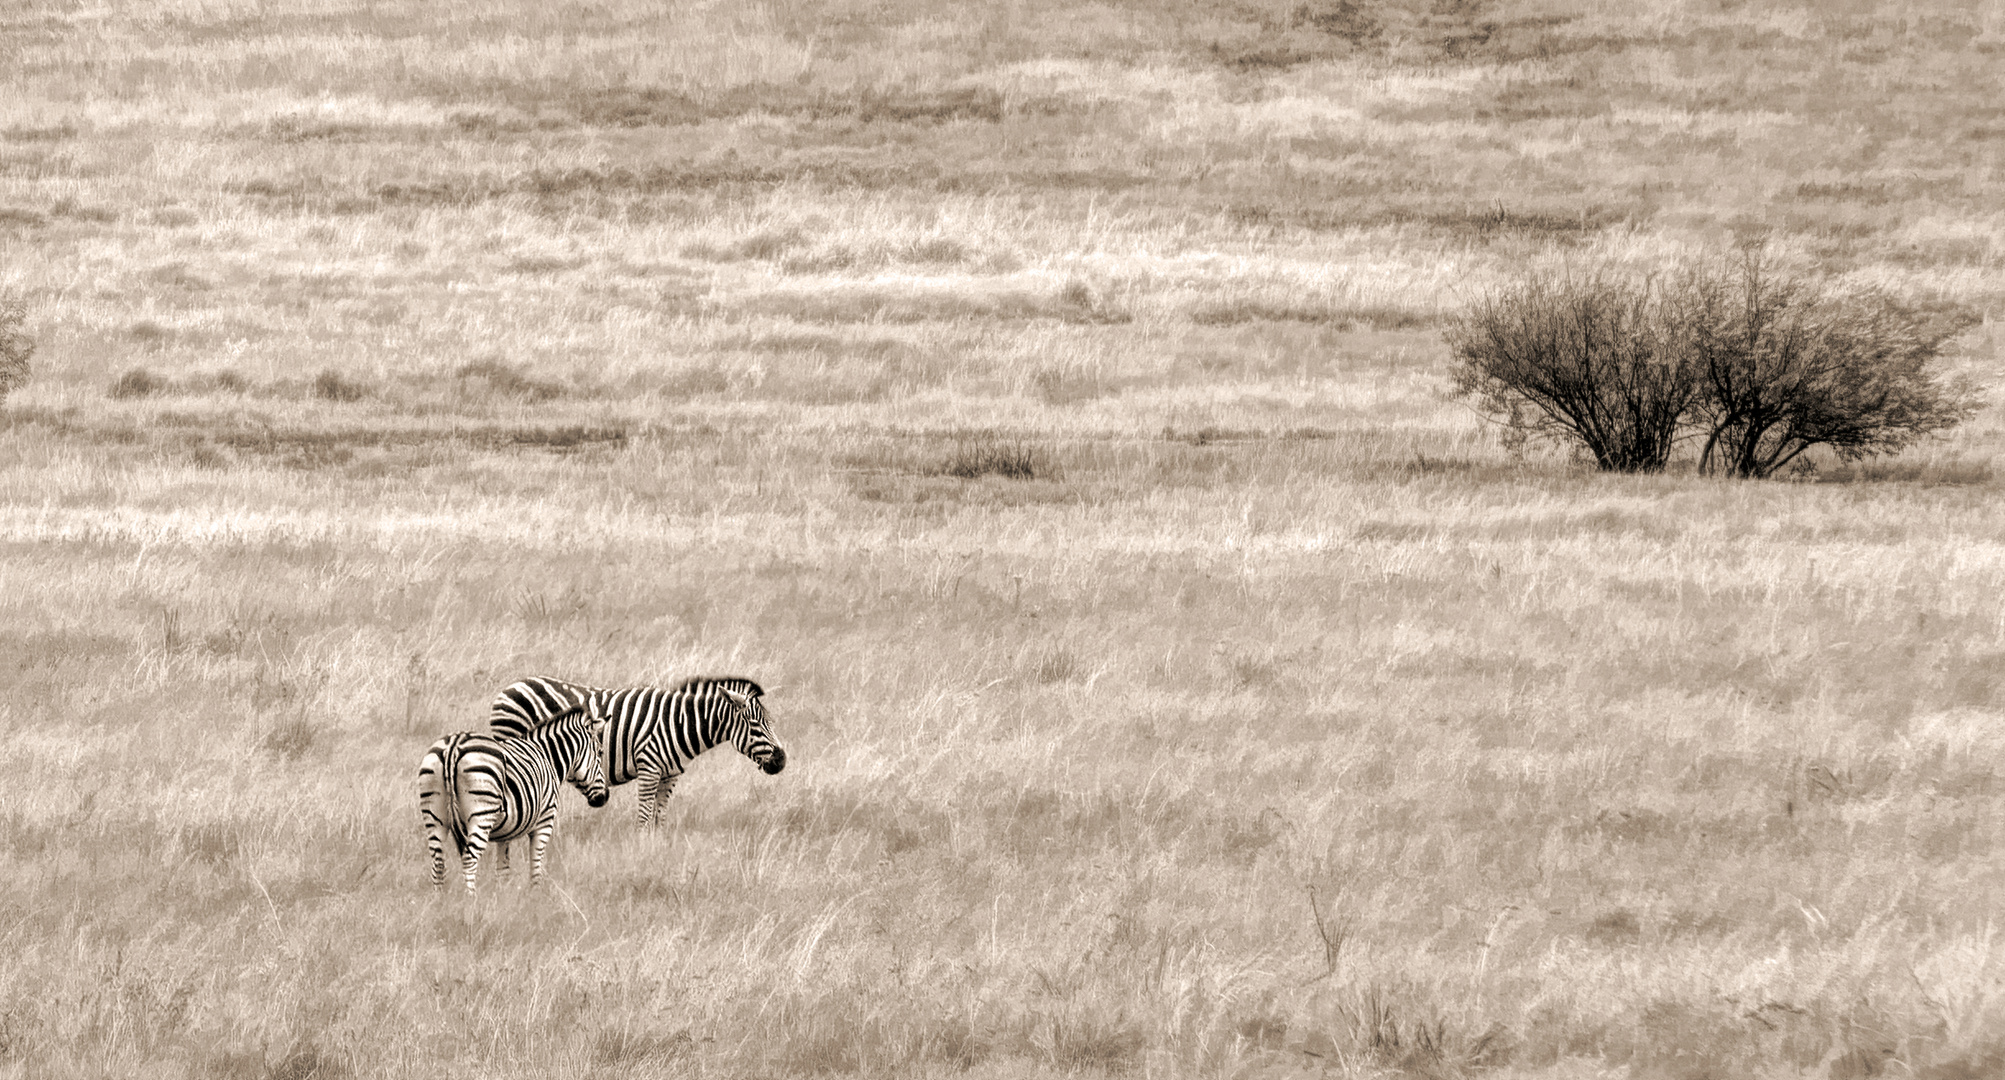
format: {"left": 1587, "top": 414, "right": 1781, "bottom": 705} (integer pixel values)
{"left": 1448, "top": 268, "right": 1700, "bottom": 473}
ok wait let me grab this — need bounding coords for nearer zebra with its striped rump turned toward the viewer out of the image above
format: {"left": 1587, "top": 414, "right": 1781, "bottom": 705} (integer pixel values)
{"left": 417, "top": 705, "right": 610, "bottom": 896}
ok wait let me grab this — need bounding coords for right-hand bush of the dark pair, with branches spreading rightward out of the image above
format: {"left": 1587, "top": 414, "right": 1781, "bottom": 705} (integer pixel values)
{"left": 1676, "top": 250, "right": 1975, "bottom": 477}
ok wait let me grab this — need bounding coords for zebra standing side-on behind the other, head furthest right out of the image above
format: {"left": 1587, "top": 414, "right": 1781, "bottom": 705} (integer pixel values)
{"left": 487, "top": 677, "right": 786, "bottom": 826}
